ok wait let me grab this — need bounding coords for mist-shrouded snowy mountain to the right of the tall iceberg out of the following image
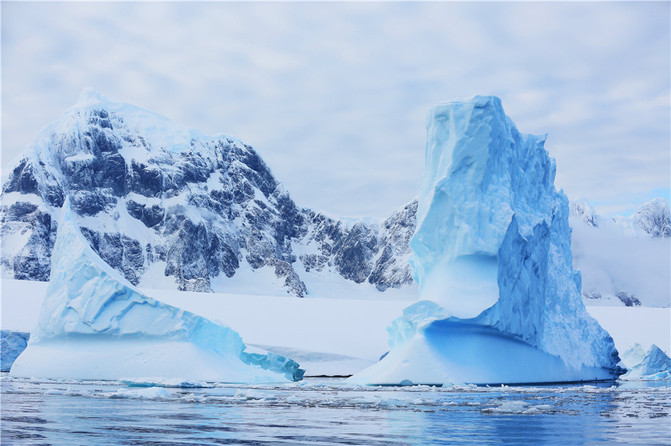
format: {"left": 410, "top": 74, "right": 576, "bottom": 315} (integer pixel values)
{"left": 570, "top": 198, "right": 671, "bottom": 307}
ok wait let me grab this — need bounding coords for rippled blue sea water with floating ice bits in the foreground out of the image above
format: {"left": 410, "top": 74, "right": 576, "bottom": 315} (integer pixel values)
{"left": 0, "top": 374, "right": 671, "bottom": 446}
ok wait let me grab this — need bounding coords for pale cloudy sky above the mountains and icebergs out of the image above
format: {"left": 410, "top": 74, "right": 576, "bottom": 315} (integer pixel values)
{"left": 1, "top": 2, "right": 671, "bottom": 218}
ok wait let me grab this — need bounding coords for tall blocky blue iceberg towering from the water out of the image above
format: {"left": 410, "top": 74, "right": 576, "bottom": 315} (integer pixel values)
{"left": 354, "top": 96, "right": 624, "bottom": 384}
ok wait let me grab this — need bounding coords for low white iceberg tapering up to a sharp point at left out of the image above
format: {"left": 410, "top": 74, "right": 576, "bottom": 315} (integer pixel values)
{"left": 10, "top": 200, "right": 303, "bottom": 383}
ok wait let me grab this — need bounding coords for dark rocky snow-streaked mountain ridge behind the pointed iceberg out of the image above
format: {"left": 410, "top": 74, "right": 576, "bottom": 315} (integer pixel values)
{"left": 0, "top": 90, "right": 416, "bottom": 297}
